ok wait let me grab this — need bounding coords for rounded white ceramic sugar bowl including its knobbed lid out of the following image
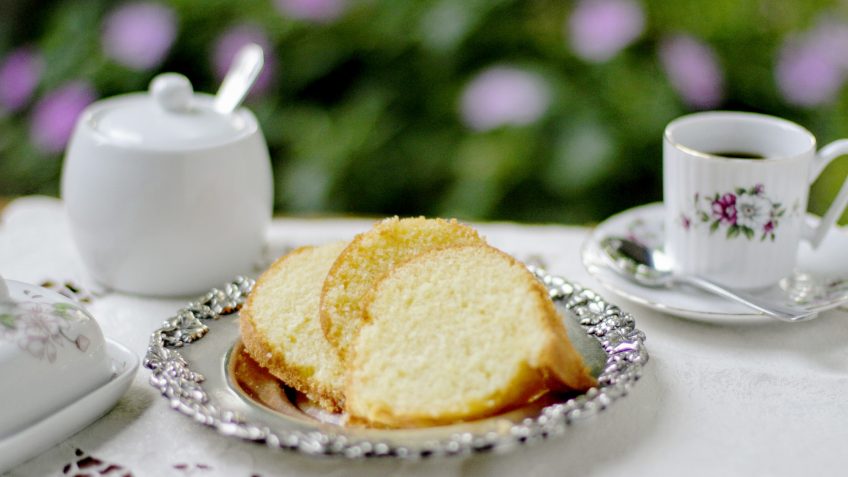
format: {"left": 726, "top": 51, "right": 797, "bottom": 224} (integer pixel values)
{"left": 62, "top": 73, "right": 273, "bottom": 296}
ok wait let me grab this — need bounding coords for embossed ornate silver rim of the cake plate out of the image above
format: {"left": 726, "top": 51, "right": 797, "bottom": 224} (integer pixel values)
{"left": 144, "top": 266, "right": 648, "bottom": 459}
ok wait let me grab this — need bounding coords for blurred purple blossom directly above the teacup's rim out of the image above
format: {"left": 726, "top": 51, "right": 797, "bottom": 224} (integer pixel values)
{"left": 659, "top": 35, "right": 724, "bottom": 109}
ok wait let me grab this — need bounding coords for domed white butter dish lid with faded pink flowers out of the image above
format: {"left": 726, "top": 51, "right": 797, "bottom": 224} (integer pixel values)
{"left": 0, "top": 277, "right": 113, "bottom": 439}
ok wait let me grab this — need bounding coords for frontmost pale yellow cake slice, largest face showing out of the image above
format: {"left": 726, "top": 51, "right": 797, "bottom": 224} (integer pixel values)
{"left": 345, "top": 245, "right": 596, "bottom": 427}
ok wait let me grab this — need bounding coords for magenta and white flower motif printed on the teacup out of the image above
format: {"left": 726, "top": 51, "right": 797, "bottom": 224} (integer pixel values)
{"left": 678, "top": 184, "right": 787, "bottom": 241}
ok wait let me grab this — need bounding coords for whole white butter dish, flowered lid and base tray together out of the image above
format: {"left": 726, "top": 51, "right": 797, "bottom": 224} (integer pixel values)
{"left": 0, "top": 278, "right": 139, "bottom": 473}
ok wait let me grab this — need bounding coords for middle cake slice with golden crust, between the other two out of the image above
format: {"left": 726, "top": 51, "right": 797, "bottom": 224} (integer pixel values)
{"left": 320, "top": 217, "right": 485, "bottom": 361}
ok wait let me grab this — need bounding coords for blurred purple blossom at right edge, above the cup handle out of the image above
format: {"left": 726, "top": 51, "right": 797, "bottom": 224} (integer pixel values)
{"left": 775, "top": 31, "right": 846, "bottom": 106}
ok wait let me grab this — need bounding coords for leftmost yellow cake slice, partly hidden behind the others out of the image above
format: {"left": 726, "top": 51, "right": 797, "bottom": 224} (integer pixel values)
{"left": 240, "top": 242, "right": 346, "bottom": 411}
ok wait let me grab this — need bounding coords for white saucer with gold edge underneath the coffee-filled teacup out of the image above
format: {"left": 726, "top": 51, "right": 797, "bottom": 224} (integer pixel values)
{"left": 582, "top": 203, "right": 848, "bottom": 323}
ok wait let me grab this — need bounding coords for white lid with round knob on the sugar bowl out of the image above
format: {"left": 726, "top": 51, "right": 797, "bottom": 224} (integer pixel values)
{"left": 83, "top": 73, "right": 257, "bottom": 150}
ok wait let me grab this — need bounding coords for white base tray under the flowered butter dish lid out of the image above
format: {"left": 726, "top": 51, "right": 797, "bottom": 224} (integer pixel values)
{"left": 0, "top": 339, "right": 139, "bottom": 474}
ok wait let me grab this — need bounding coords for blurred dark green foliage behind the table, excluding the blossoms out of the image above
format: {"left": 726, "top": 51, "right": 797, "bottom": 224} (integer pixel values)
{"left": 0, "top": 0, "right": 848, "bottom": 223}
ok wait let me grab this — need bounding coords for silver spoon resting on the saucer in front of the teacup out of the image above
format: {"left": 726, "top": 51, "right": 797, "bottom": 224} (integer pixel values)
{"left": 600, "top": 237, "right": 817, "bottom": 322}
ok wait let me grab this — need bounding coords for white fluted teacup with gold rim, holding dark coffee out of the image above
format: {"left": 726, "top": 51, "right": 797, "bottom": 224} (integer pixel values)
{"left": 663, "top": 111, "right": 848, "bottom": 289}
